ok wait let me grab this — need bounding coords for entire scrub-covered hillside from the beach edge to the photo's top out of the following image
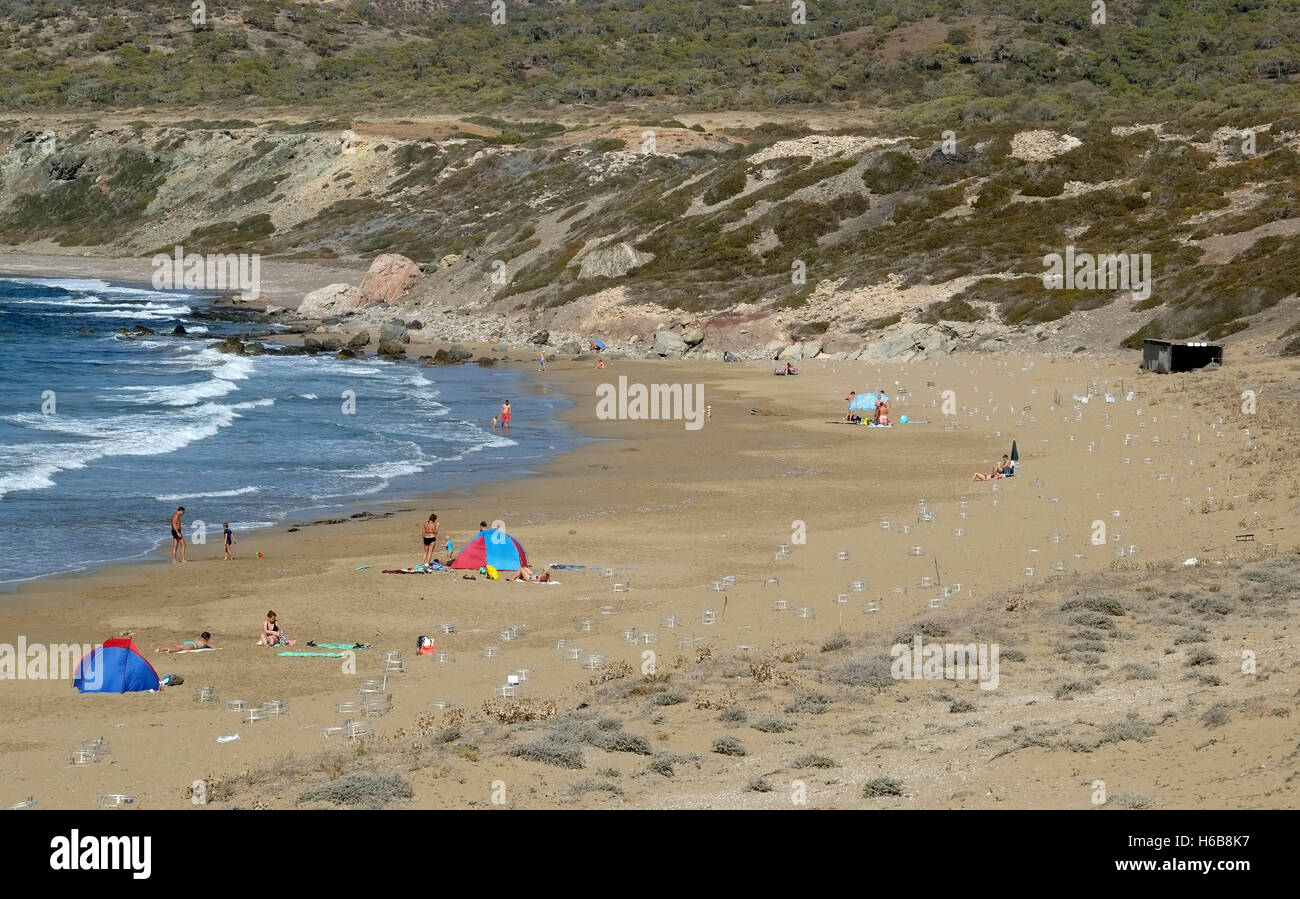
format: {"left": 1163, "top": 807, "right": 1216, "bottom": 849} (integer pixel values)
{"left": 0, "top": 0, "right": 1300, "bottom": 356}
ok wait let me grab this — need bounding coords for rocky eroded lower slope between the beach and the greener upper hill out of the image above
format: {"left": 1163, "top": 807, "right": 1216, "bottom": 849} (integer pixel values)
{"left": 0, "top": 117, "right": 1300, "bottom": 361}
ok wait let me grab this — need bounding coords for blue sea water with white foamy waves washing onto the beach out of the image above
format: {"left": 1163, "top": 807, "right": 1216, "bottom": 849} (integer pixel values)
{"left": 0, "top": 277, "right": 576, "bottom": 587}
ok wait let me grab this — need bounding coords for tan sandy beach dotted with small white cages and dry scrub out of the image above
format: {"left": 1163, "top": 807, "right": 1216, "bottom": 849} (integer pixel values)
{"left": 0, "top": 348, "right": 1300, "bottom": 808}
